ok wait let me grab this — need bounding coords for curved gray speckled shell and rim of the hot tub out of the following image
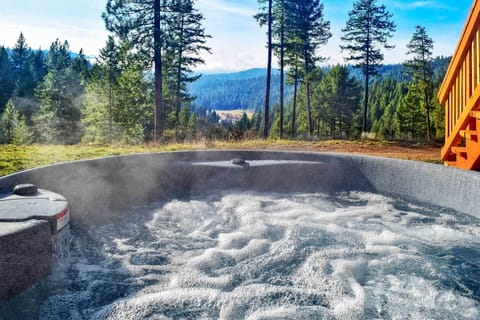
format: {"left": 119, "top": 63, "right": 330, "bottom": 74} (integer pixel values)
{"left": 0, "top": 151, "right": 480, "bottom": 298}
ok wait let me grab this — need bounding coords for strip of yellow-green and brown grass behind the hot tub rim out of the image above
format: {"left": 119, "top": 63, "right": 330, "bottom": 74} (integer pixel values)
{"left": 0, "top": 140, "right": 440, "bottom": 176}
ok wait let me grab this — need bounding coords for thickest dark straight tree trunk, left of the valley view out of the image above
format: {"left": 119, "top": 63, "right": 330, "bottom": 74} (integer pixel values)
{"left": 153, "top": 0, "right": 165, "bottom": 141}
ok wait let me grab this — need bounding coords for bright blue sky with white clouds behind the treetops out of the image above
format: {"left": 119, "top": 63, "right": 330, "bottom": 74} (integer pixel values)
{"left": 0, "top": 0, "right": 472, "bottom": 72}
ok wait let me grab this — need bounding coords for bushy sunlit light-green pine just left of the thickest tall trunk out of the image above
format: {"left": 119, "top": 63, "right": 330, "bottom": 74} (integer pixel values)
{"left": 82, "top": 43, "right": 153, "bottom": 144}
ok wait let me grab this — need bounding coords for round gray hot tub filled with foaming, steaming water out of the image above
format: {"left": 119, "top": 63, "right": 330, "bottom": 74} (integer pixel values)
{"left": 0, "top": 151, "right": 480, "bottom": 319}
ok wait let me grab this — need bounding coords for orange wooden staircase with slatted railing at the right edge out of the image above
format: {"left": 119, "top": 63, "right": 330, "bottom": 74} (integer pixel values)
{"left": 438, "top": 0, "right": 480, "bottom": 170}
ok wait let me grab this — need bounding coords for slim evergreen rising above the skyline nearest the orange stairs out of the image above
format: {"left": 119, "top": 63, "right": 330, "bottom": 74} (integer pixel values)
{"left": 404, "top": 26, "right": 433, "bottom": 141}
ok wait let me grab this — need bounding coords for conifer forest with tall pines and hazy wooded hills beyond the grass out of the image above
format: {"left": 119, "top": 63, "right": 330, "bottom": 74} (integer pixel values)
{"left": 0, "top": 0, "right": 450, "bottom": 145}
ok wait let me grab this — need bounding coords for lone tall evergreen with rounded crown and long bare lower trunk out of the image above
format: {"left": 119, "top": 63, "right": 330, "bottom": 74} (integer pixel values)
{"left": 340, "top": 0, "right": 396, "bottom": 132}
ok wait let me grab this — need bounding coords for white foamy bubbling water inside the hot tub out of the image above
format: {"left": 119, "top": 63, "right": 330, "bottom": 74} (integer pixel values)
{"left": 0, "top": 192, "right": 480, "bottom": 319}
